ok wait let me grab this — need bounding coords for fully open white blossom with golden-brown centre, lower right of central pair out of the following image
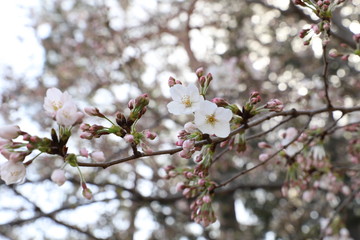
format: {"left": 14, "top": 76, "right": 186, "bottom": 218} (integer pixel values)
{"left": 194, "top": 100, "right": 232, "bottom": 138}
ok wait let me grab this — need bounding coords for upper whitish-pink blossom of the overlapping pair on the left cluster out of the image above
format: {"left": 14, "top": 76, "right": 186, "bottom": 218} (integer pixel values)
{"left": 43, "top": 88, "right": 72, "bottom": 117}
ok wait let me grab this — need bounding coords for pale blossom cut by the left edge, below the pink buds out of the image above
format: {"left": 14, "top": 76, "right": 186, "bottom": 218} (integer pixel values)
{"left": 0, "top": 161, "right": 26, "bottom": 185}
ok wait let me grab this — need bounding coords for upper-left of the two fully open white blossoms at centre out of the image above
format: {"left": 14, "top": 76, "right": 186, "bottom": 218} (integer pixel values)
{"left": 167, "top": 84, "right": 204, "bottom": 115}
